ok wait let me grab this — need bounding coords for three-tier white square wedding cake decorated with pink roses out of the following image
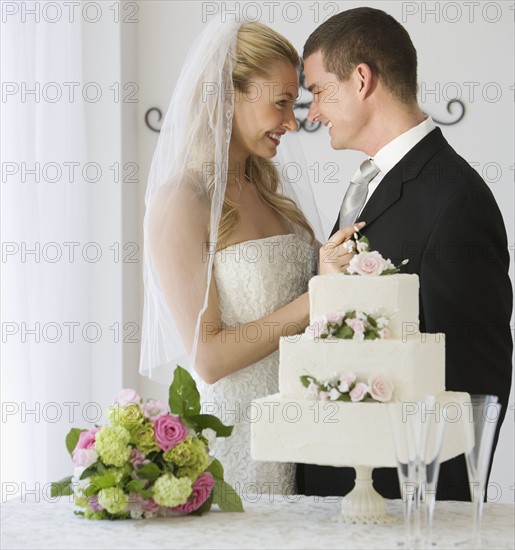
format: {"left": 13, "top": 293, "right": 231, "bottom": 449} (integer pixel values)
{"left": 251, "top": 235, "right": 469, "bottom": 524}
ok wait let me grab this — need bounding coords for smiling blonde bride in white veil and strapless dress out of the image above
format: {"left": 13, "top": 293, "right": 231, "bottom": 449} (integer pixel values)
{"left": 140, "top": 22, "right": 360, "bottom": 494}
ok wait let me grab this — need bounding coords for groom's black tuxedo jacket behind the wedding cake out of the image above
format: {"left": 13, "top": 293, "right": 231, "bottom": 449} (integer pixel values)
{"left": 297, "top": 128, "right": 513, "bottom": 500}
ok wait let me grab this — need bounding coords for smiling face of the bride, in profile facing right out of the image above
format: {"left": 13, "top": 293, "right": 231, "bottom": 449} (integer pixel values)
{"left": 231, "top": 62, "right": 299, "bottom": 162}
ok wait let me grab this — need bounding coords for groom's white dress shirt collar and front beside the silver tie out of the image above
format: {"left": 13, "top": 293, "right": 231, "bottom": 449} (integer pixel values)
{"left": 356, "top": 116, "right": 435, "bottom": 221}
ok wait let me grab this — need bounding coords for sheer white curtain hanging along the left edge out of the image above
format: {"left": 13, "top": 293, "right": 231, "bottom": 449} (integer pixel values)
{"left": 0, "top": 1, "right": 94, "bottom": 499}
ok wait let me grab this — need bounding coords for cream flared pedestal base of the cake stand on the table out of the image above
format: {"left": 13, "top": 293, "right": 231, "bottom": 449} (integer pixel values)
{"left": 333, "top": 466, "right": 399, "bottom": 524}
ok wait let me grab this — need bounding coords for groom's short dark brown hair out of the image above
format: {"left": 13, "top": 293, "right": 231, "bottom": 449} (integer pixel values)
{"left": 303, "top": 8, "right": 417, "bottom": 103}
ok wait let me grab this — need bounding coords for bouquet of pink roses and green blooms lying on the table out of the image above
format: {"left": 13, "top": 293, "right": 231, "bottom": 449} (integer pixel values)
{"left": 51, "top": 366, "right": 243, "bottom": 519}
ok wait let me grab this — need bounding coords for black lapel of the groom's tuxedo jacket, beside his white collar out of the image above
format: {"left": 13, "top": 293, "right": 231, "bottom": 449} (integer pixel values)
{"left": 358, "top": 128, "right": 447, "bottom": 226}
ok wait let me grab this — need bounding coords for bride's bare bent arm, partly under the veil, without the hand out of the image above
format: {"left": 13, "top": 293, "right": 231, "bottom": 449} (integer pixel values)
{"left": 149, "top": 188, "right": 309, "bottom": 383}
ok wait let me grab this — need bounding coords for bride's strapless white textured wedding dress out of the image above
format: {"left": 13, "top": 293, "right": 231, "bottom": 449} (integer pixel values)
{"left": 199, "top": 234, "right": 316, "bottom": 498}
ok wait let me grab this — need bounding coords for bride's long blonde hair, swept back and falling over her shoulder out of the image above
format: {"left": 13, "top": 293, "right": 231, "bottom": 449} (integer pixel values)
{"left": 217, "top": 23, "right": 315, "bottom": 248}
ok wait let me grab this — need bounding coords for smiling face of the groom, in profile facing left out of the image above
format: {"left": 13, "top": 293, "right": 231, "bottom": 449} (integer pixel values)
{"left": 304, "top": 51, "right": 364, "bottom": 149}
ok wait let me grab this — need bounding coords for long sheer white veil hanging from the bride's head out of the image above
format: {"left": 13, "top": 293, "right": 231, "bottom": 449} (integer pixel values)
{"left": 140, "top": 20, "right": 323, "bottom": 384}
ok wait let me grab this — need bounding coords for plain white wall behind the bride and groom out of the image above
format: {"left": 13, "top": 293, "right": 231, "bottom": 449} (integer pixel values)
{"left": 132, "top": 1, "right": 515, "bottom": 502}
